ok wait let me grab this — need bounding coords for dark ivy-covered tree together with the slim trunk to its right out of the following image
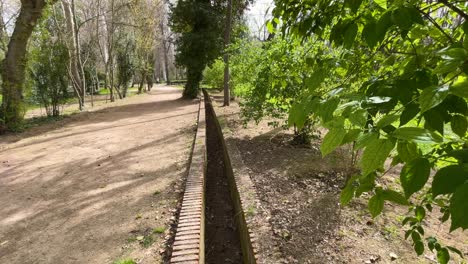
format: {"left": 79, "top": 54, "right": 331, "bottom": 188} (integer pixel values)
{"left": 170, "top": 0, "right": 249, "bottom": 99}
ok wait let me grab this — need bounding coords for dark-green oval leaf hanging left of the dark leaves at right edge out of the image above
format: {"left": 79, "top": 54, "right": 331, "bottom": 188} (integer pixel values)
{"left": 400, "top": 158, "right": 431, "bottom": 198}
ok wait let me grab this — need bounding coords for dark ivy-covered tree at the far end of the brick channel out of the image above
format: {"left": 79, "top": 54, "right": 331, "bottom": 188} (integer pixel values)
{"left": 170, "top": 0, "right": 224, "bottom": 98}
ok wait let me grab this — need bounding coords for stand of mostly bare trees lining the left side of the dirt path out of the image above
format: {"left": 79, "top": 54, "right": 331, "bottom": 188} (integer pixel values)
{"left": 0, "top": 0, "right": 176, "bottom": 131}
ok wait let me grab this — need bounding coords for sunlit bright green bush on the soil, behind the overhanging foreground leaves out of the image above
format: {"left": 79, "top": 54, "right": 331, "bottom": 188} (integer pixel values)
{"left": 230, "top": 38, "right": 322, "bottom": 142}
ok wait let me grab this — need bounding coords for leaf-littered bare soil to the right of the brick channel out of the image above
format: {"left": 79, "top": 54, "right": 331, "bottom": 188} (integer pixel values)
{"left": 215, "top": 98, "right": 468, "bottom": 264}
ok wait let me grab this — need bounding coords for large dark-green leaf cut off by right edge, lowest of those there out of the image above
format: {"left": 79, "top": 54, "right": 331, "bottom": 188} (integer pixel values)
{"left": 449, "top": 182, "right": 468, "bottom": 232}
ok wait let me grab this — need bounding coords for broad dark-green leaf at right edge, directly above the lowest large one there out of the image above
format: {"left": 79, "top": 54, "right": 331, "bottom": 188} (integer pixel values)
{"left": 432, "top": 165, "right": 468, "bottom": 197}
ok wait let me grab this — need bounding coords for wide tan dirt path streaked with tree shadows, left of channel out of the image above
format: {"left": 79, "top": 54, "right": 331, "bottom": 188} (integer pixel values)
{"left": 0, "top": 87, "right": 198, "bottom": 264}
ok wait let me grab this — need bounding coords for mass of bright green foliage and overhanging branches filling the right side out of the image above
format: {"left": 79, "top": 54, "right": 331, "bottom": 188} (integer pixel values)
{"left": 258, "top": 0, "right": 468, "bottom": 258}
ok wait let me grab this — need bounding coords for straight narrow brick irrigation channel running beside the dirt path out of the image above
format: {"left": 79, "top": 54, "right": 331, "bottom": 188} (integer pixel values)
{"left": 170, "top": 90, "right": 279, "bottom": 264}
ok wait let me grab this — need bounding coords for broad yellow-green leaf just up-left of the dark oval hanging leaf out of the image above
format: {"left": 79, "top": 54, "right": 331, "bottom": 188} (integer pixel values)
{"left": 360, "top": 139, "right": 395, "bottom": 175}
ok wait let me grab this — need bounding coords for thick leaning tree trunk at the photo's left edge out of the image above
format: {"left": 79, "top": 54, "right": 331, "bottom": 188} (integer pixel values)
{"left": 0, "top": 0, "right": 46, "bottom": 131}
